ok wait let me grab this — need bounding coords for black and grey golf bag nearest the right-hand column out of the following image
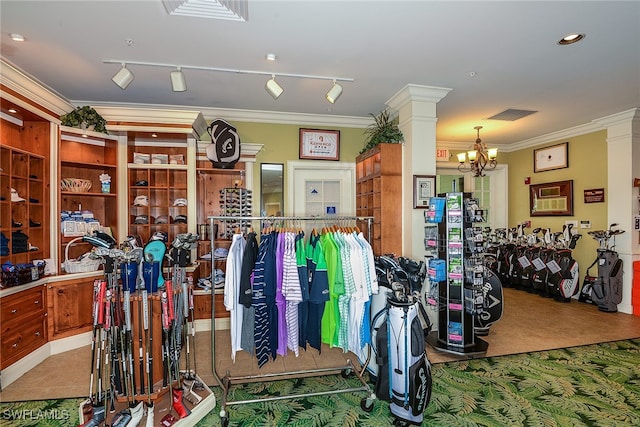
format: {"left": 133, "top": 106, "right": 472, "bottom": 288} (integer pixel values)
{"left": 580, "top": 249, "right": 623, "bottom": 313}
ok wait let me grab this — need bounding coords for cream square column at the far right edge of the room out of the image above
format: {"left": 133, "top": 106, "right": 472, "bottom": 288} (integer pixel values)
{"left": 595, "top": 108, "right": 640, "bottom": 314}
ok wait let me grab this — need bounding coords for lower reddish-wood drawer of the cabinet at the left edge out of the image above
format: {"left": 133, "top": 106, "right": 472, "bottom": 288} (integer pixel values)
{"left": 0, "top": 316, "right": 47, "bottom": 369}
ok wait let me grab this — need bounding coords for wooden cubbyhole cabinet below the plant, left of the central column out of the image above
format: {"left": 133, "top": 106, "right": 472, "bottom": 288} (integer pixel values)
{"left": 356, "top": 144, "right": 402, "bottom": 256}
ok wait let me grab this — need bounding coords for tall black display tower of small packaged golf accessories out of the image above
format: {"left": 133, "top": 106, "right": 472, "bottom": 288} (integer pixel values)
{"left": 427, "top": 192, "right": 489, "bottom": 355}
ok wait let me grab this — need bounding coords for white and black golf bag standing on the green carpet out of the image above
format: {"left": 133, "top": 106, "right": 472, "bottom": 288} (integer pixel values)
{"left": 375, "top": 296, "right": 432, "bottom": 425}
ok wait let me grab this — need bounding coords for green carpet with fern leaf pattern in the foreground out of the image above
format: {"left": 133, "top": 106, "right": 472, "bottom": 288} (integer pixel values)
{"left": 0, "top": 339, "right": 640, "bottom": 427}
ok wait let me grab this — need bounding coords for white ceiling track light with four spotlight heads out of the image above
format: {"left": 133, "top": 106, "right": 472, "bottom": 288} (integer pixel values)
{"left": 102, "top": 59, "right": 355, "bottom": 100}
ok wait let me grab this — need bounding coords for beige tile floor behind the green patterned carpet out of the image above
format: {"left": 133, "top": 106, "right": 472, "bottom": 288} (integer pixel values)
{"left": 0, "top": 289, "right": 640, "bottom": 401}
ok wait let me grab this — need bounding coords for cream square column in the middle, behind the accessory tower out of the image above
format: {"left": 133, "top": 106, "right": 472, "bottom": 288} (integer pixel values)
{"left": 387, "top": 84, "right": 451, "bottom": 260}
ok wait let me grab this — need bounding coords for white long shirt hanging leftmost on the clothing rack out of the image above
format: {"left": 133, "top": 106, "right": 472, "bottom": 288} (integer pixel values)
{"left": 224, "top": 234, "right": 245, "bottom": 362}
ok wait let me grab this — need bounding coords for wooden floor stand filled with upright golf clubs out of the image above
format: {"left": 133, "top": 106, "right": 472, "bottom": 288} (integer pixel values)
{"left": 79, "top": 233, "right": 215, "bottom": 427}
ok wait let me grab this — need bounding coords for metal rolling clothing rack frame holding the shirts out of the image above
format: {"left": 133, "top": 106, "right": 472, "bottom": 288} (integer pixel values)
{"left": 208, "top": 215, "right": 376, "bottom": 427}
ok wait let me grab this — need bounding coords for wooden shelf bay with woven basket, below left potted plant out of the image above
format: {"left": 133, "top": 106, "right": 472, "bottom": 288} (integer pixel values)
{"left": 56, "top": 126, "right": 118, "bottom": 268}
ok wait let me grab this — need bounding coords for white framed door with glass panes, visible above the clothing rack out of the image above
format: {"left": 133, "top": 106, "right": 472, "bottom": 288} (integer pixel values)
{"left": 287, "top": 161, "right": 356, "bottom": 221}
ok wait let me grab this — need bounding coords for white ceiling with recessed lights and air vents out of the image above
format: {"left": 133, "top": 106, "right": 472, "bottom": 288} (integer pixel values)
{"left": 0, "top": 0, "right": 640, "bottom": 145}
